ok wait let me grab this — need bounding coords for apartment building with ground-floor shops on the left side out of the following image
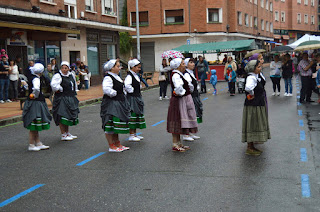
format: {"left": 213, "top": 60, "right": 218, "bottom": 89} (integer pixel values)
{"left": 0, "top": 0, "right": 135, "bottom": 83}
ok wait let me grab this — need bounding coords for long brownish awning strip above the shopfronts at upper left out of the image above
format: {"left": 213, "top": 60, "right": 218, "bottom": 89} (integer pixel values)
{"left": 0, "top": 21, "right": 80, "bottom": 34}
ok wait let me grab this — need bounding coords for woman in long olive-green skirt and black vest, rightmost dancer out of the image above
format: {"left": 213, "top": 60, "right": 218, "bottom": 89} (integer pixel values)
{"left": 242, "top": 60, "right": 271, "bottom": 156}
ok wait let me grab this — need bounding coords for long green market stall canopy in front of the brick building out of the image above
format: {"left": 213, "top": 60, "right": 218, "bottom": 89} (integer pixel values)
{"left": 174, "top": 40, "right": 257, "bottom": 54}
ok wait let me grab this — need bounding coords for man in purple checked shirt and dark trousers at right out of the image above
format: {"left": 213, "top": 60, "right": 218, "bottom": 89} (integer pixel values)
{"left": 298, "top": 53, "right": 313, "bottom": 103}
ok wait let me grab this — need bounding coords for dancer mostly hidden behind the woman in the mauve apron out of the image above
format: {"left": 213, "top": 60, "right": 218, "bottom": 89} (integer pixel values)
{"left": 183, "top": 58, "right": 203, "bottom": 141}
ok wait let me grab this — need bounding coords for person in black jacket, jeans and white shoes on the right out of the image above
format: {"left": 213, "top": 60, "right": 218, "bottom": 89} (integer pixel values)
{"left": 282, "top": 54, "right": 293, "bottom": 96}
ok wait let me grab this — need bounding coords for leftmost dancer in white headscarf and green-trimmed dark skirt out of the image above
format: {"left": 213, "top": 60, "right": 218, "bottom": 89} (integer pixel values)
{"left": 22, "top": 63, "right": 52, "bottom": 151}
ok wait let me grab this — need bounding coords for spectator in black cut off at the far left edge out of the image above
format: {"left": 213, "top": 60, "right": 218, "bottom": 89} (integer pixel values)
{"left": 0, "top": 55, "right": 11, "bottom": 103}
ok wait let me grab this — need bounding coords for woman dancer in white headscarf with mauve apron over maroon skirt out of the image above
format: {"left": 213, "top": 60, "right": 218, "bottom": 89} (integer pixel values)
{"left": 167, "top": 58, "right": 198, "bottom": 152}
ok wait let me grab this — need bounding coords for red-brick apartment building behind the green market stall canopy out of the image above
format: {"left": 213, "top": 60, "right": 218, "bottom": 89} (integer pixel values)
{"left": 127, "top": 0, "right": 274, "bottom": 71}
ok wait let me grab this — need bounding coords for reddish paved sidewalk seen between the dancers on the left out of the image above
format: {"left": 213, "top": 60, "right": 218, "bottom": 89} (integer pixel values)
{"left": 0, "top": 72, "right": 159, "bottom": 126}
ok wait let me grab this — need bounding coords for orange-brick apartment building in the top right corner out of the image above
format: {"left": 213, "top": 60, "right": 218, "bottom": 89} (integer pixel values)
{"left": 273, "top": 0, "right": 318, "bottom": 45}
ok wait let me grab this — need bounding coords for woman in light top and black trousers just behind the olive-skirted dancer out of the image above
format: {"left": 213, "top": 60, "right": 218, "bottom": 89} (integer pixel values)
{"left": 270, "top": 55, "right": 282, "bottom": 96}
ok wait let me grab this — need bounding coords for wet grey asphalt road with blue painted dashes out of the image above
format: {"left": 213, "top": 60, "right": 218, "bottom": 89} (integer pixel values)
{"left": 0, "top": 70, "right": 320, "bottom": 212}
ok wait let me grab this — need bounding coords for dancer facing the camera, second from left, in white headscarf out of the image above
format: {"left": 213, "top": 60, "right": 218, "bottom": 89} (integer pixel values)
{"left": 51, "top": 61, "right": 80, "bottom": 141}
